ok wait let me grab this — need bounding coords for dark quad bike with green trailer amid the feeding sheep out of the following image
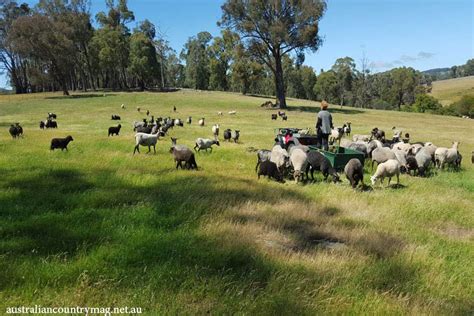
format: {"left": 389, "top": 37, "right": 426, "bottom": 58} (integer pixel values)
{"left": 275, "top": 128, "right": 365, "bottom": 171}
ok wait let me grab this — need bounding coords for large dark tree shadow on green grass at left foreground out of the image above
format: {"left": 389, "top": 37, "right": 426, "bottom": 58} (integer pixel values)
{"left": 0, "top": 169, "right": 314, "bottom": 289}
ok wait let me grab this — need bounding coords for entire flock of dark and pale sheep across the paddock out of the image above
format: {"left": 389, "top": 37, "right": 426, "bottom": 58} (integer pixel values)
{"left": 4, "top": 104, "right": 474, "bottom": 188}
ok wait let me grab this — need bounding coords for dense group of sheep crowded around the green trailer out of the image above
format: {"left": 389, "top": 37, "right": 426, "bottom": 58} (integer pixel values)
{"left": 255, "top": 124, "right": 466, "bottom": 188}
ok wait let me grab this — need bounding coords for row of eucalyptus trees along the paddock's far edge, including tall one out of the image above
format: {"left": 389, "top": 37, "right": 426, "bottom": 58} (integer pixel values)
{"left": 0, "top": 0, "right": 474, "bottom": 113}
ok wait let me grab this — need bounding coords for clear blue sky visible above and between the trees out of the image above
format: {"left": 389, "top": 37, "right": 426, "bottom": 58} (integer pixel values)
{"left": 0, "top": 0, "right": 474, "bottom": 87}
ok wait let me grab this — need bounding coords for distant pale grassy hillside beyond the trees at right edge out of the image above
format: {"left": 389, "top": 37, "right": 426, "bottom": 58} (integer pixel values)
{"left": 431, "top": 76, "right": 474, "bottom": 105}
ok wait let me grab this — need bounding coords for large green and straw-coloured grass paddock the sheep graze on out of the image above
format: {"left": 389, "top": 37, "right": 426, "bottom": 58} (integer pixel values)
{"left": 0, "top": 91, "right": 474, "bottom": 315}
